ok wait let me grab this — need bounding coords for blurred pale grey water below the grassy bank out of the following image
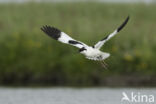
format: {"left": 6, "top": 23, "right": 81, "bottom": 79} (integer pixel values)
{"left": 0, "top": 88, "right": 156, "bottom": 104}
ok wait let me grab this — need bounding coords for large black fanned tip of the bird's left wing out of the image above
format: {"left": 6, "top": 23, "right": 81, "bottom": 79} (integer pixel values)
{"left": 41, "top": 25, "right": 61, "bottom": 40}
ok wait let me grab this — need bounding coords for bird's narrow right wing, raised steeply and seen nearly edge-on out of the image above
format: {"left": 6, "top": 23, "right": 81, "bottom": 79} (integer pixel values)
{"left": 94, "top": 16, "right": 129, "bottom": 49}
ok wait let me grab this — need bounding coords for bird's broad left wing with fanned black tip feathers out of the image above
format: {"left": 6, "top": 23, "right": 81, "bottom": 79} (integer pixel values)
{"left": 41, "top": 26, "right": 87, "bottom": 48}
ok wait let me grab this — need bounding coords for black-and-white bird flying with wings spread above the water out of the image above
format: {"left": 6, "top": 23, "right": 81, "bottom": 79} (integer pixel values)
{"left": 41, "top": 16, "right": 129, "bottom": 66}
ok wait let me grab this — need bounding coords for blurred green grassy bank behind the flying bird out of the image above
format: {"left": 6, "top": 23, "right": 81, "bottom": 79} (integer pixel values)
{"left": 0, "top": 3, "right": 156, "bottom": 86}
